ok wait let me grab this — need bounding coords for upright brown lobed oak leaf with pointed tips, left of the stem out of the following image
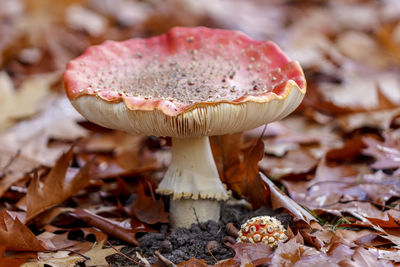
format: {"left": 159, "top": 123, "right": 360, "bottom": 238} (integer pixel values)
{"left": 26, "top": 147, "right": 93, "bottom": 222}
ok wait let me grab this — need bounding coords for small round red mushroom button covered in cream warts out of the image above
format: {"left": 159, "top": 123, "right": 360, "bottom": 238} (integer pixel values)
{"left": 238, "top": 216, "right": 288, "bottom": 247}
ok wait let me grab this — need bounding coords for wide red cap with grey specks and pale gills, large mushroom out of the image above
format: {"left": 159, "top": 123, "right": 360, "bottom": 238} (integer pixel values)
{"left": 63, "top": 27, "right": 306, "bottom": 137}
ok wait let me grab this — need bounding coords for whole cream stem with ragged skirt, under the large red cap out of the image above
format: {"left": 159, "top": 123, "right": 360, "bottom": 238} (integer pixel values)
{"left": 157, "top": 136, "right": 228, "bottom": 227}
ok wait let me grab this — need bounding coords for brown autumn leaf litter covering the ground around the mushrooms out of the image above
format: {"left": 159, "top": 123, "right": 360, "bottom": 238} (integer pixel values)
{"left": 0, "top": 0, "right": 400, "bottom": 266}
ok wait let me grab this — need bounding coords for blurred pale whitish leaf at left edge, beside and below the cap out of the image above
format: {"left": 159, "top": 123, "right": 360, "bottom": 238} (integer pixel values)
{"left": 0, "top": 94, "right": 87, "bottom": 166}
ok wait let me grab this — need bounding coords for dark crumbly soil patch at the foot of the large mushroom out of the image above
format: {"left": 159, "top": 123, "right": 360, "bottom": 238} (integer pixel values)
{"left": 106, "top": 205, "right": 292, "bottom": 267}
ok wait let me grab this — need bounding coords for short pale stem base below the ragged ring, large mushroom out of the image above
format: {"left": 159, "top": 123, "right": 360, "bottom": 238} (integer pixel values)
{"left": 169, "top": 199, "right": 221, "bottom": 228}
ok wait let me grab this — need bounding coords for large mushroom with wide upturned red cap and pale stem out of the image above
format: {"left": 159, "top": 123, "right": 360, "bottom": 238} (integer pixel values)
{"left": 63, "top": 27, "right": 306, "bottom": 227}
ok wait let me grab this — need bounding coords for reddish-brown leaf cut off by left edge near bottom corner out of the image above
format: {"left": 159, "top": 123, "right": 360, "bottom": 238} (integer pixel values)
{"left": 0, "top": 209, "right": 47, "bottom": 251}
